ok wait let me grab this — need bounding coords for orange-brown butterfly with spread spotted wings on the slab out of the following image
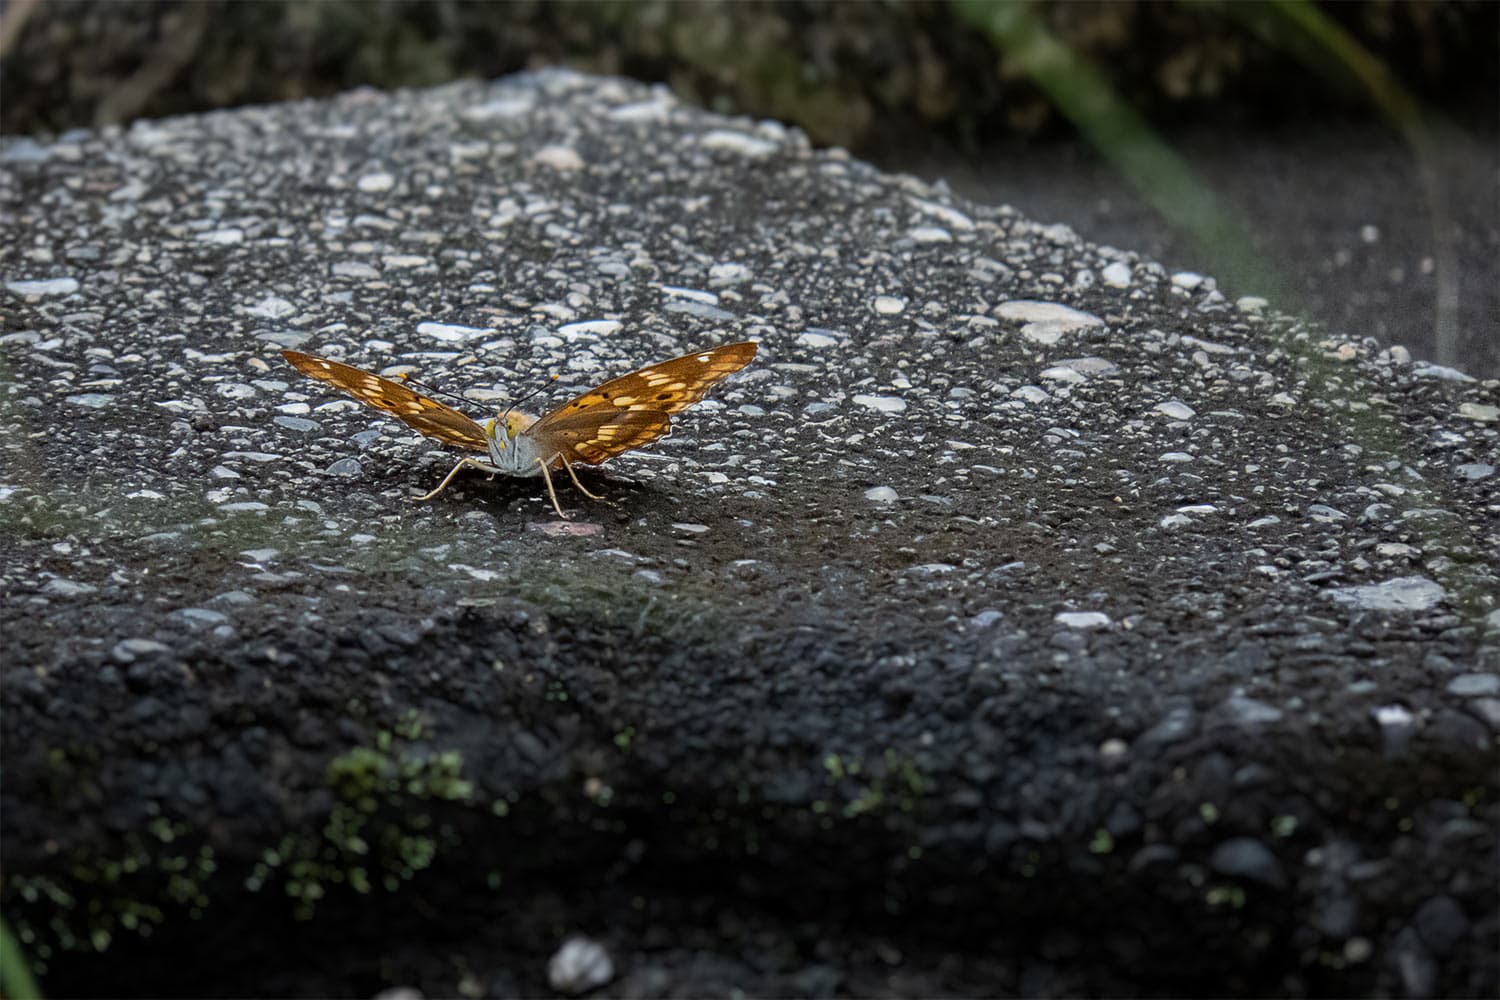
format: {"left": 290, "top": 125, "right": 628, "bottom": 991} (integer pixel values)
{"left": 282, "top": 340, "right": 756, "bottom": 519}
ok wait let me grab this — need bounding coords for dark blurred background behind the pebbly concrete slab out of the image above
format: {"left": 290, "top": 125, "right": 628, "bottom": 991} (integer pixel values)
{"left": 0, "top": 0, "right": 1500, "bottom": 376}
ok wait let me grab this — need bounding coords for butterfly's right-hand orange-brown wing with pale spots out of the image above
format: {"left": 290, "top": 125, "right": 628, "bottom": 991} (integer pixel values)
{"left": 524, "top": 340, "right": 756, "bottom": 465}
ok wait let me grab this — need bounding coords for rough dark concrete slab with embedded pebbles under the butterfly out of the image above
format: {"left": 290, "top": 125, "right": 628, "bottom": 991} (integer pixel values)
{"left": 0, "top": 73, "right": 1500, "bottom": 996}
